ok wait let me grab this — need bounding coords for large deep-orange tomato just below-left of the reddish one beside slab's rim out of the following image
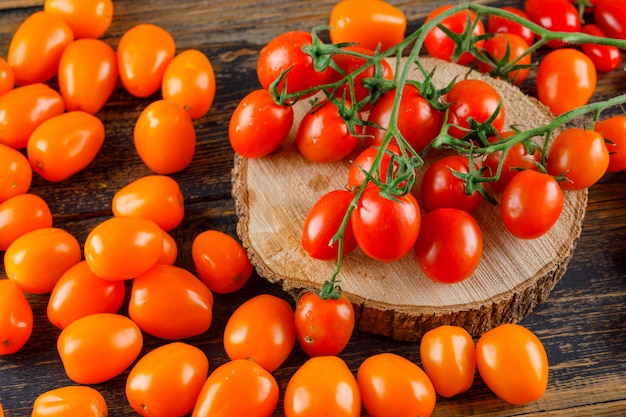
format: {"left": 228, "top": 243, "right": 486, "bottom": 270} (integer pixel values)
{"left": 128, "top": 264, "right": 213, "bottom": 340}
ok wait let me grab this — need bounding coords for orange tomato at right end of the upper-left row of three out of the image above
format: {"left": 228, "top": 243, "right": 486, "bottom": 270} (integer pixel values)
{"left": 161, "top": 49, "right": 216, "bottom": 119}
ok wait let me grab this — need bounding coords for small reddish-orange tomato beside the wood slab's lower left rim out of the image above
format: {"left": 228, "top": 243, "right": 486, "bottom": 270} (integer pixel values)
{"left": 191, "top": 230, "right": 253, "bottom": 294}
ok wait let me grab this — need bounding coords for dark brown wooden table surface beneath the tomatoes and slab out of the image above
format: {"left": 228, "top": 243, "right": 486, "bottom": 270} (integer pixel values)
{"left": 0, "top": 0, "right": 626, "bottom": 417}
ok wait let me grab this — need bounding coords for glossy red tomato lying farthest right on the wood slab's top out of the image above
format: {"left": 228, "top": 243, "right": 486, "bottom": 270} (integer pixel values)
{"left": 500, "top": 170, "right": 564, "bottom": 239}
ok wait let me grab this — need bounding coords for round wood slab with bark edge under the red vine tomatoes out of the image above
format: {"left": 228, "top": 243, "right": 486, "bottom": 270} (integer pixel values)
{"left": 233, "top": 58, "right": 587, "bottom": 341}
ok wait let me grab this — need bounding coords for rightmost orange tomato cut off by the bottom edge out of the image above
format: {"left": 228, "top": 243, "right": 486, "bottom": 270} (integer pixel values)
{"left": 357, "top": 353, "right": 437, "bottom": 417}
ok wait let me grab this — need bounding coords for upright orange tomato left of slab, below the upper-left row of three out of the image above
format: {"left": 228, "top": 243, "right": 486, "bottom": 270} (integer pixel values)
{"left": 133, "top": 100, "right": 196, "bottom": 175}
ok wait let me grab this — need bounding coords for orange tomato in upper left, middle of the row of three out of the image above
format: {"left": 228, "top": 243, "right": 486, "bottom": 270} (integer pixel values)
{"left": 117, "top": 23, "right": 176, "bottom": 97}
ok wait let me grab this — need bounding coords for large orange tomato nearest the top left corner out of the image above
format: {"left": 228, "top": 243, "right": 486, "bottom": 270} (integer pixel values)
{"left": 7, "top": 10, "right": 74, "bottom": 85}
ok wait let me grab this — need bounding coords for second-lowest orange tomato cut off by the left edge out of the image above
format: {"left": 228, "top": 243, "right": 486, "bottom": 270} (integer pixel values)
{"left": 0, "top": 194, "right": 52, "bottom": 251}
